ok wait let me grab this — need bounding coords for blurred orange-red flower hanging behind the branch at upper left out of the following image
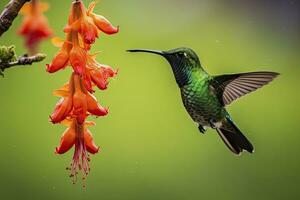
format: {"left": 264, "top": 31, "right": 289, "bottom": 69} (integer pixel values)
{"left": 18, "top": 0, "right": 52, "bottom": 54}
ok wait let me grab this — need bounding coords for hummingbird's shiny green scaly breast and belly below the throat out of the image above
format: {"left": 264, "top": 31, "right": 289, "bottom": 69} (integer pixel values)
{"left": 181, "top": 77, "right": 224, "bottom": 126}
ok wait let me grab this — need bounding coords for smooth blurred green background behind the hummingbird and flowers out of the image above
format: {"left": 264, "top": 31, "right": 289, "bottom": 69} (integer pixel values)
{"left": 0, "top": 0, "right": 300, "bottom": 200}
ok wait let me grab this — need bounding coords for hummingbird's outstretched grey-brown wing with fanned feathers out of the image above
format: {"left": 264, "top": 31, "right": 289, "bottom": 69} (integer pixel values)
{"left": 211, "top": 72, "right": 279, "bottom": 106}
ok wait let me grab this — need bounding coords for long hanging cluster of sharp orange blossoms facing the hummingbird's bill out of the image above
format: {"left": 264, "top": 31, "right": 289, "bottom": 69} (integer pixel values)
{"left": 46, "top": 1, "right": 119, "bottom": 185}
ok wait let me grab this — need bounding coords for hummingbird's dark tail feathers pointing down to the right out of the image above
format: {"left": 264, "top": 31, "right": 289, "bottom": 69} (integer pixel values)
{"left": 216, "top": 118, "right": 254, "bottom": 154}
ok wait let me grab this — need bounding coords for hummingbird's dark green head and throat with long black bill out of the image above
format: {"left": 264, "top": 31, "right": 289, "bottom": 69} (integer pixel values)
{"left": 127, "top": 47, "right": 202, "bottom": 87}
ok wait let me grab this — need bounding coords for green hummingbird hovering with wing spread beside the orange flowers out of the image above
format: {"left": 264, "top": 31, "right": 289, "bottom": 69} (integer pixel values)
{"left": 127, "top": 47, "right": 279, "bottom": 155}
